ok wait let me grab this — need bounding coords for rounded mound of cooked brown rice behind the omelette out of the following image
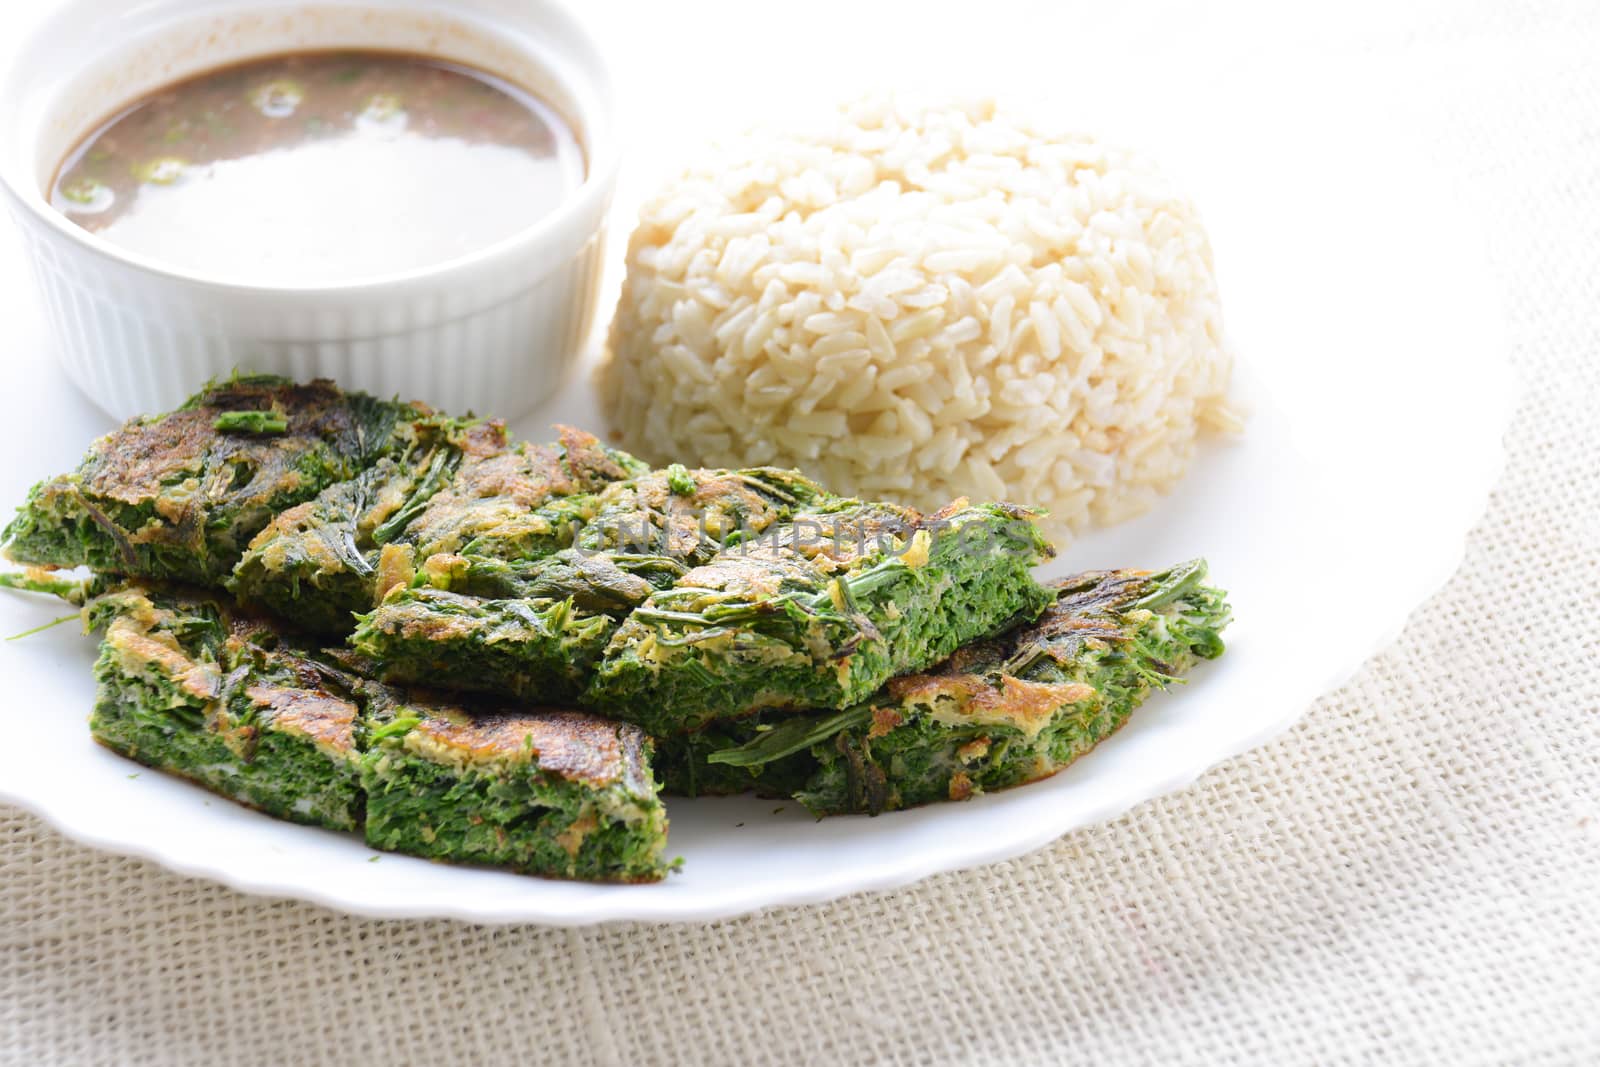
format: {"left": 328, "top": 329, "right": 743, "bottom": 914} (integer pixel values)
{"left": 600, "top": 99, "right": 1237, "bottom": 534}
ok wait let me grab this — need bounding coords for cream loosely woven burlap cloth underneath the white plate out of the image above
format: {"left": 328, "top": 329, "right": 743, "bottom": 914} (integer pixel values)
{"left": 0, "top": 3, "right": 1600, "bottom": 1067}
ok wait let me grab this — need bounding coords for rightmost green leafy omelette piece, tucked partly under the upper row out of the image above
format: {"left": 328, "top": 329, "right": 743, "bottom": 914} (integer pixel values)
{"left": 658, "top": 560, "right": 1229, "bottom": 814}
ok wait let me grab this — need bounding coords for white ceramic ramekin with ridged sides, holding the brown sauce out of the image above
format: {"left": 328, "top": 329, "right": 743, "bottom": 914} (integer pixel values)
{"left": 0, "top": 0, "right": 618, "bottom": 418}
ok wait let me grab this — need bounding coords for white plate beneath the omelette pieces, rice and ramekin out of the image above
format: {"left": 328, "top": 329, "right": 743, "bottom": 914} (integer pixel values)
{"left": 0, "top": 112, "right": 1514, "bottom": 923}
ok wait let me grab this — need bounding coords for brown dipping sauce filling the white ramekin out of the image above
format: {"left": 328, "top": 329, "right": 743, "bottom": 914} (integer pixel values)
{"left": 50, "top": 51, "right": 584, "bottom": 285}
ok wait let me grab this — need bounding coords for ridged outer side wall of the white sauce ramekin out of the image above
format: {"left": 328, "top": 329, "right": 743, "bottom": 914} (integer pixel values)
{"left": 9, "top": 221, "right": 605, "bottom": 419}
